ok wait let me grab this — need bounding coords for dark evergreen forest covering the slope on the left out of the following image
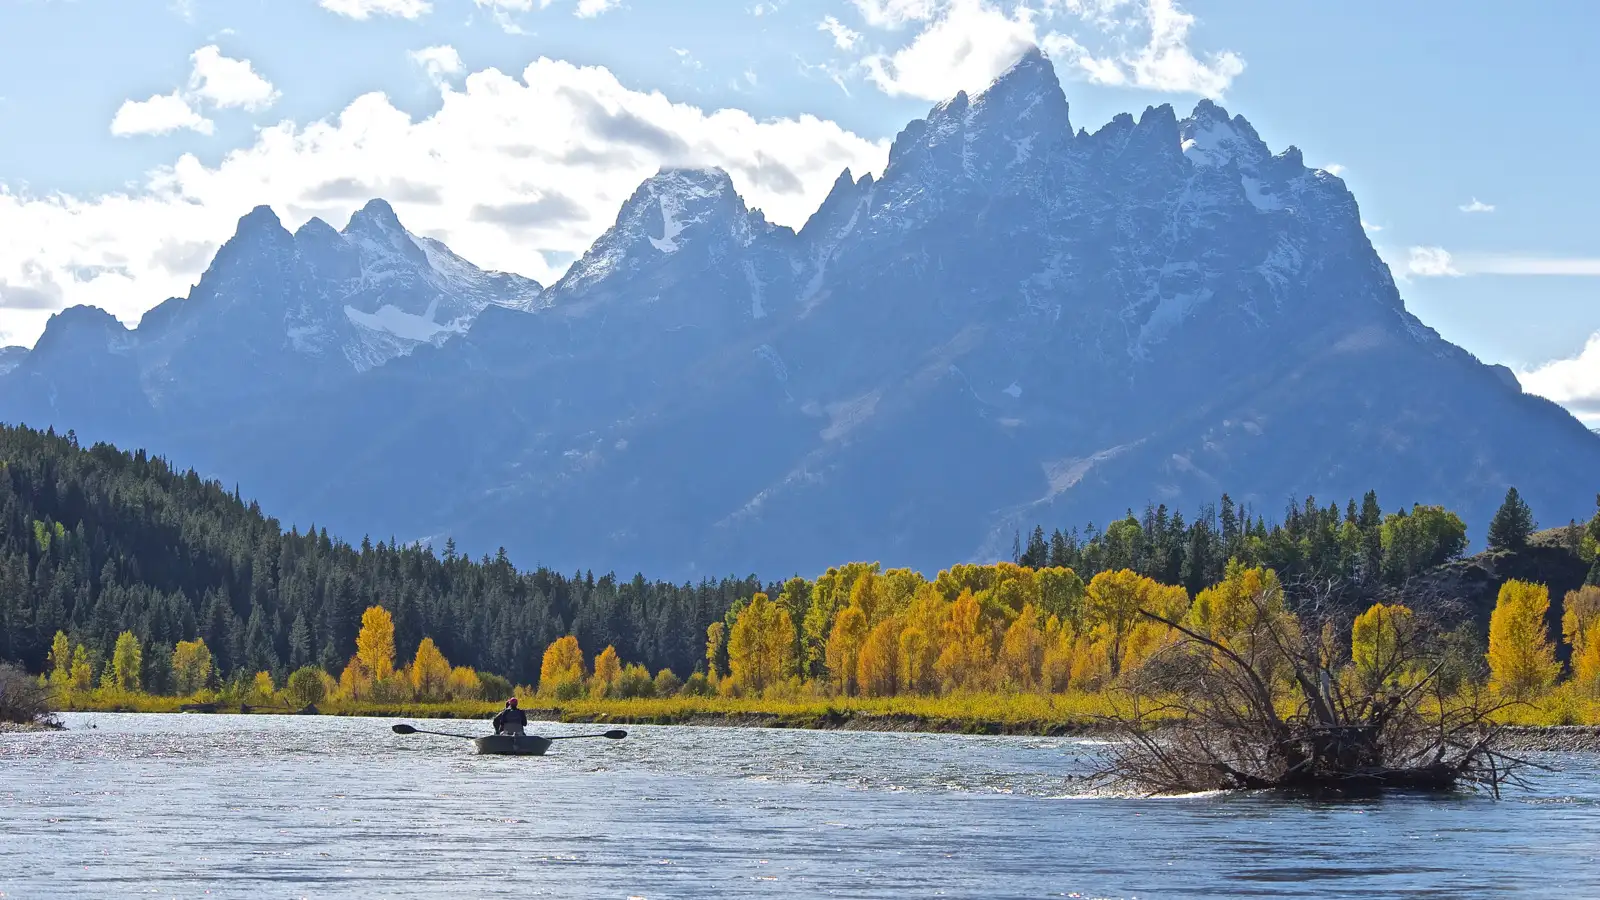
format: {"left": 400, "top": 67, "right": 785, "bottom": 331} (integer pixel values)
{"left": 0, "top": 428, "right": 776, "bottom": 684}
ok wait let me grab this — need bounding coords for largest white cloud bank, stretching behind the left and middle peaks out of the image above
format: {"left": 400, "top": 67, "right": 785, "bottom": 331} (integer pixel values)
{"left": 0, "top": 59, "right": 888, "bottom": 343}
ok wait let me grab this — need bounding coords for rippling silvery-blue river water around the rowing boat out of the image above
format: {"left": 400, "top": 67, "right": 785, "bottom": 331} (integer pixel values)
{"left": 0, "top": 714, "right": 1600, "bottom": 900}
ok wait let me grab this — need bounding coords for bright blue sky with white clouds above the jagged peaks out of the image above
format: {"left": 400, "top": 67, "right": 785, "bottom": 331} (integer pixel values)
{"left": 0, "top": 0, "right": 1600, "bottom": 421}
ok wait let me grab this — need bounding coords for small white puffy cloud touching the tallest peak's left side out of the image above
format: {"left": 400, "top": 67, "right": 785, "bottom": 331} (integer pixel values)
{"left": 862, "top": 0, "right": 1037, "bottom": 99}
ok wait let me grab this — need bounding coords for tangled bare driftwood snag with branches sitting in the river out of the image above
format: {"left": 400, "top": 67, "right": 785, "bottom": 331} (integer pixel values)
{"left": 1099, "top": 573, "right": 1530, "bottom": 796}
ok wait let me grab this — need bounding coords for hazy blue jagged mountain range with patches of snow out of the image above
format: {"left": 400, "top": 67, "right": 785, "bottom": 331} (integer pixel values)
{"left": 0, "top": 51, "right": 1600, "bottom": 578}
